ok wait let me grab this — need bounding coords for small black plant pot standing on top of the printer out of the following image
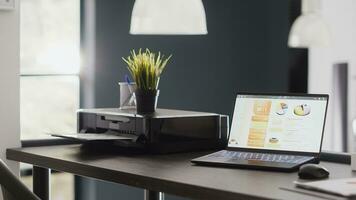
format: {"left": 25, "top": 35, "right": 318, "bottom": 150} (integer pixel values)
{"left": 135, "top": 89, "right": 159, "bottom": 114}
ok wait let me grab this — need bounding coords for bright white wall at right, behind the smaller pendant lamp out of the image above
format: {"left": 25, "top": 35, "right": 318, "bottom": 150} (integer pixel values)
{"left": 308, "top": 0, "right": 356, "bottom": 151}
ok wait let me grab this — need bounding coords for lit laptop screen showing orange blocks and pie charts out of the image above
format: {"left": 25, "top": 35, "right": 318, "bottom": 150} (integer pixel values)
{"left": 228, "top": 95, "right": 327, "bottom": 153}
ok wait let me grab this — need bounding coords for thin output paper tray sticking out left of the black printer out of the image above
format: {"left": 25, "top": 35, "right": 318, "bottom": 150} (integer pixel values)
{"left": 51, "top": 133, "right": 137, "bottom": 142}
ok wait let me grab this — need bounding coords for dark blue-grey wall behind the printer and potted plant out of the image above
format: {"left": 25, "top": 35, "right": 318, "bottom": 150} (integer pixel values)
{"left": 81, "top": 0, "right": 306, "bottom": 200}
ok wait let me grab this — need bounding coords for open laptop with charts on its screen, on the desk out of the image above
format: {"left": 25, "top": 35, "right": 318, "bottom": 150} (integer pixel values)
{"left": 191, "top": 93, "right": 329, "bottom": 171}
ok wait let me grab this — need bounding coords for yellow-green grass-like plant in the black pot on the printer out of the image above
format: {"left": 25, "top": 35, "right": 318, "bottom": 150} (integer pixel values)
{"left": 122, "top": 49, "right": 172, "bottom": 91}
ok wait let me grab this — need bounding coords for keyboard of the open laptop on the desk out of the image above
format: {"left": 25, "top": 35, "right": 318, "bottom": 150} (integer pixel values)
{"left": 210, "top": 150, "right": 312, "bottom": 164}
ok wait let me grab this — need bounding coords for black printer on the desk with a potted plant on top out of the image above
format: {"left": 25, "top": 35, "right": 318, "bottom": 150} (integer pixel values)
{"left": 77, "top": 108, "right": 229, "bottom": 153}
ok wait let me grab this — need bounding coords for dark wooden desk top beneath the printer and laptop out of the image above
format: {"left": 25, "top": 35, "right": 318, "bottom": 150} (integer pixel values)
{"left": 7, "top": 145, "right": 356, "bottom": 200}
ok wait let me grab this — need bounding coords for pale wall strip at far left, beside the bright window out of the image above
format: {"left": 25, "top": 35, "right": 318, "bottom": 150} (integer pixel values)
{"left": 0, "top": 0, "right": 20, "bottom": 195}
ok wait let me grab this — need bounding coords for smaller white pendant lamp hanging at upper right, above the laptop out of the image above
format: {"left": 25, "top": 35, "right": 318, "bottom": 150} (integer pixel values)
{"left": 288, "top": 0, "right": 330, "bottom": 48}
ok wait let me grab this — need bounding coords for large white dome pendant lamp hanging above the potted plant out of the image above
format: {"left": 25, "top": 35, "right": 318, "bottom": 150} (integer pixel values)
{"left": 130, "top": 0, "right": 208, "bottom": 35}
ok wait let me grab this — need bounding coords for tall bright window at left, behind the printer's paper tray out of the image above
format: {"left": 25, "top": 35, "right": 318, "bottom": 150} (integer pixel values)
{"left": 20, "top": 0, "right": 80, "bottom": 140}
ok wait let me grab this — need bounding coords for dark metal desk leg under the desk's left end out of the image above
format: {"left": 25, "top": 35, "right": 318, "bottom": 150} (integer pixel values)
{"left": 33, "top": 166, "right": 51, "bottom": 200}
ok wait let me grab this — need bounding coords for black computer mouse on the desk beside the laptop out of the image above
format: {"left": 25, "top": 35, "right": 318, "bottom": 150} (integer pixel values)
{"left": 298, "top": 164, "right": 330, "bottom": 179}
